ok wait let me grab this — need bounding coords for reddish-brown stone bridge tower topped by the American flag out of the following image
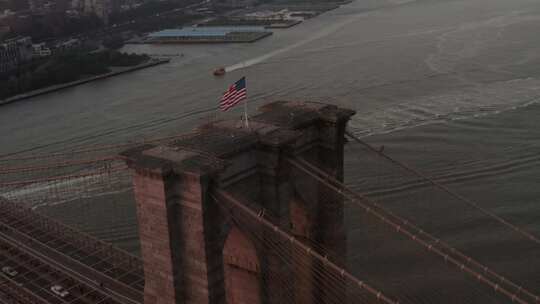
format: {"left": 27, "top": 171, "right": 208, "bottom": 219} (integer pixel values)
{"left": 123, "top": 102, "right": 354, "bottom": 304}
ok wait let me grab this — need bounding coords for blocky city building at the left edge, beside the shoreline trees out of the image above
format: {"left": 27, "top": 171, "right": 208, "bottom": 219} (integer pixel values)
{"left": 0, "top": 37, "right": 33, "bottom": 73}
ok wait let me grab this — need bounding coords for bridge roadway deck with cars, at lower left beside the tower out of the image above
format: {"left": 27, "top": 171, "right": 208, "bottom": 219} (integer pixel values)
{"left": 0, "top": 198, "right": 144, "bottom": 304}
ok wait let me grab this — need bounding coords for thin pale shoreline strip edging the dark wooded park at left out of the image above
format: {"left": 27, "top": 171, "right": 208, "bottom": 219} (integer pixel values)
{"left": 0, "top": 58, "right": 171, "bottom": 106}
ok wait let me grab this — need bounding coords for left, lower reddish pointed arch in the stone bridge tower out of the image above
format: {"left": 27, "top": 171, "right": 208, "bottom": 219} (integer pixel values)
{"left": 223, "top": 227, "right": 261, "bottom": 304}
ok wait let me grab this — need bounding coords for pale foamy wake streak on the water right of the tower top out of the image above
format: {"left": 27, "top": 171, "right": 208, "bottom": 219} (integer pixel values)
{"left": 350, "top": 78, "right": 540, "bottom": 137}
